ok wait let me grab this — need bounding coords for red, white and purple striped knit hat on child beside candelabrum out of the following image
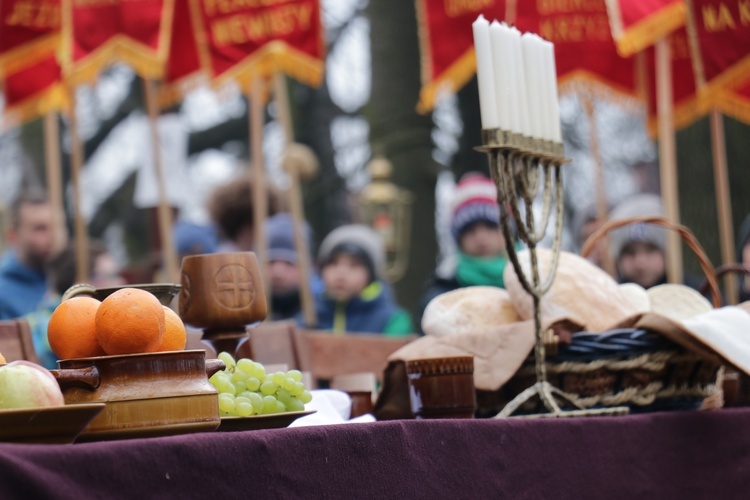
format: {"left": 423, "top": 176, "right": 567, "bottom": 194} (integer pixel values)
{"left": 451, "top": 173, "right": 500, "bottom": 243}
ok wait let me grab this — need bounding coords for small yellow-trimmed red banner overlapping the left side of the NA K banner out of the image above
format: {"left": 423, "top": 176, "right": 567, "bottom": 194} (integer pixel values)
{"left": 606, "top": 0, "right": 685, "bottom": 57}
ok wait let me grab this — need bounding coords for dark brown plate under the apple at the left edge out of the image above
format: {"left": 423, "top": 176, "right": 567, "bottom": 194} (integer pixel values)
{"left": 0, "top": 403, "right": 105, "bottom": 444}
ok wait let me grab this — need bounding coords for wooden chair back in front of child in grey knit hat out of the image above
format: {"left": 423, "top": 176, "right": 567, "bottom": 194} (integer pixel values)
{"left": 294, "top": 329, "right": 417, "bottom": 382}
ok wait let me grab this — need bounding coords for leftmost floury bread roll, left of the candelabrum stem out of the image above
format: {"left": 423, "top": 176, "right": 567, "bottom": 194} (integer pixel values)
{"left": 422, "top": 286, "right": 521, "bottom": 337}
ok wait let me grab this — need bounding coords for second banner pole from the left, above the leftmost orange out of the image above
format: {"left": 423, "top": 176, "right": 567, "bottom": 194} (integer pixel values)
{"left": 68, "top": 86, "right": 89, "bottom": 283}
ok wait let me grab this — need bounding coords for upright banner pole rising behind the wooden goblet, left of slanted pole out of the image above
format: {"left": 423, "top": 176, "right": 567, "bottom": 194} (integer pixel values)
{"left": 247, "top": 76, "right": 271, "bottom": 302}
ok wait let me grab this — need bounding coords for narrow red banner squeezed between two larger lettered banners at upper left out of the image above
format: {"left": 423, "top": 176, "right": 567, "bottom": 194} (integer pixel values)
{"left": 159, "top": 0, "right": 203, "bottom": 107}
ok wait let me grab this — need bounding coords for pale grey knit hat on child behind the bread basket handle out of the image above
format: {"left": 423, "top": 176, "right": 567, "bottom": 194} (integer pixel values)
{"left": 609, "top": 194, "right": 667, "bottom": 260}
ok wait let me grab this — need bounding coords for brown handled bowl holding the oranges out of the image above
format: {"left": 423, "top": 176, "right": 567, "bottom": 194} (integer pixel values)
{"left": 51, "top": 350, "right": 225, "bottom": 441}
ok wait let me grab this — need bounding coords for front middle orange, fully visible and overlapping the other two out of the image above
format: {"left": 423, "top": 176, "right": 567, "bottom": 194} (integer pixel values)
{"left": 96, "top": 288, "right": 164, "bottom": 355}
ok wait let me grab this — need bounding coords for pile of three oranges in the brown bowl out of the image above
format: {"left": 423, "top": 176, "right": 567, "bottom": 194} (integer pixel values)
{"left": 47, "top": 288, "right": 187, "bottom": 359}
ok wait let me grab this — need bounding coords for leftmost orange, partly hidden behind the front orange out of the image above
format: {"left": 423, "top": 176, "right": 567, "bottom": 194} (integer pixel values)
{"left": 47, "top": 297, "right": 104, "bottom": 359}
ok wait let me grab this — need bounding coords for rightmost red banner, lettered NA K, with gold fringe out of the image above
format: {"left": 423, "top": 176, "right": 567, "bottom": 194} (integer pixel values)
{"left": 686, "top": 0, "right": 750, "bottom": 101}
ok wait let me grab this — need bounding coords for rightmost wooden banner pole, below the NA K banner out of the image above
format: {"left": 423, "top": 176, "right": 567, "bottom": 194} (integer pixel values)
{"left": 709, "top": 108, "right": 740, "bottom": 305}
